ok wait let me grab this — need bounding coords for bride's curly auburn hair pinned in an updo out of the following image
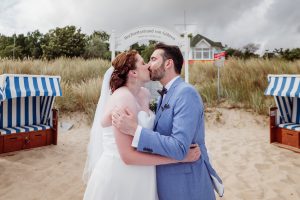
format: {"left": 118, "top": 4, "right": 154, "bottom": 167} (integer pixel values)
{"left": 109, "top": 50, "right": 138, "bottom": 93}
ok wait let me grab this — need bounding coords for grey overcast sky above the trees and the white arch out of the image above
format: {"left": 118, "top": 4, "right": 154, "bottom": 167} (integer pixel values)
{"left": 0, "top": 0, "right": 300, "bottom": 51}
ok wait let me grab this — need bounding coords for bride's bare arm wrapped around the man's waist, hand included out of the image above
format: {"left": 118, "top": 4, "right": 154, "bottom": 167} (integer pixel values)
{"left": 114, "top": 128, "right": 200, "bottom": 165}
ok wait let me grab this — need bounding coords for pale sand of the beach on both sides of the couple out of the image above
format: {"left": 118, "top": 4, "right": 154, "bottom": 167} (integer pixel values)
{"left": 0, "top": 108, "right": 300, "bottom": 200}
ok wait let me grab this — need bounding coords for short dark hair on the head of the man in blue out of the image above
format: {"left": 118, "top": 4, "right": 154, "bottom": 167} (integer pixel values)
{"left": 154, "top": 43, "right": 183, "bottom": 74}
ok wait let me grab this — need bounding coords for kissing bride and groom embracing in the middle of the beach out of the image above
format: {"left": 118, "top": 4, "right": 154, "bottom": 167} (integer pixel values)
{"left": 84, "top": 43, "right": 224, "bottom": 200}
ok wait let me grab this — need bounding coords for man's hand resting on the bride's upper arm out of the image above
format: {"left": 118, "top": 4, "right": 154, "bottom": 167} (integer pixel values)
{"left": 112, "top": 107, "right": 138, "bottom": 136}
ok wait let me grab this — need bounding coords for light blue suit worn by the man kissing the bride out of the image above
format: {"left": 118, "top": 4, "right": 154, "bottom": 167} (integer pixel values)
{"left": 137, "top": 78, "right": 221, "bottom": 200}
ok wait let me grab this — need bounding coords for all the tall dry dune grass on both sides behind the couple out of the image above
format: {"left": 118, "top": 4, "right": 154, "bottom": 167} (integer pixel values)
{"left": 0, "top": 58, "right": 300, "bottom": 121}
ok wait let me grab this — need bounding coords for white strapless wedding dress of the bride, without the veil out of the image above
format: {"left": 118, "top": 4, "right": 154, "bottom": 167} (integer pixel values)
{"left": 84, "top": 111, "right": 158, "bottom": 200}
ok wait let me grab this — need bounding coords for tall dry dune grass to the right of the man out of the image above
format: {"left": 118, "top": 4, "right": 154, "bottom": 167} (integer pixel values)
{"left": 190, "top": 59, "right": 300, "bottom": 114}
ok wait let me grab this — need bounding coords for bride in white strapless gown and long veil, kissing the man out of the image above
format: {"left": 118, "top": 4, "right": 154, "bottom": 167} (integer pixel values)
{"left": 84, "top": 50, "right": 200, "bottom": 200}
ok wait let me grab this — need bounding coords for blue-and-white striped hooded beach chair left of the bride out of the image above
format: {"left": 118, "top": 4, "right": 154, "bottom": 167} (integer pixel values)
{"left": 0, "top": 74, "right": 62, "bottom": 153}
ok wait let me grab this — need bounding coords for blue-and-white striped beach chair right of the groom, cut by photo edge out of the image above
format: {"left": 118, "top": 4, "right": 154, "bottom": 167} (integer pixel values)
{"left": 265, "top": 75, "right": 300, "bottom": 149}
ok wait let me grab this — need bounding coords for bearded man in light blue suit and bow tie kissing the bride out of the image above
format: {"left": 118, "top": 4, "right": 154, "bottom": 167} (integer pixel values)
{"left": 112, "top": 43, "right": 221, "bottom": 200}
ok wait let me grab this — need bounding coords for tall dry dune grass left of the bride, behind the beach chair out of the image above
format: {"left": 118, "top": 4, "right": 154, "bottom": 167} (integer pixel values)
{"left": 0, "top": 58, "right": 110, "bottom": 122}
